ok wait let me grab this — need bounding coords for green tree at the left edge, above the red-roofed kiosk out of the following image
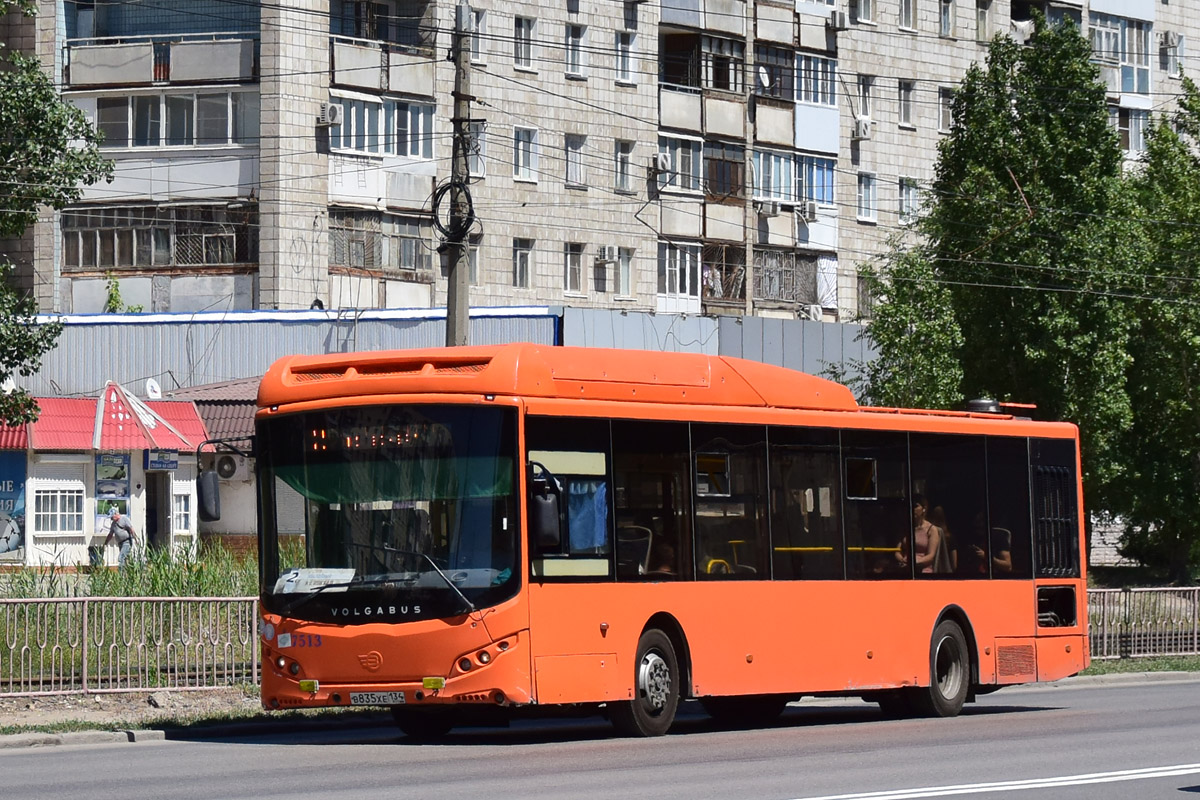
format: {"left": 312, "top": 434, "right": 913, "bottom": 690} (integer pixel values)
{"left": 0, "top": 0, "right": 112, "bottom": 423}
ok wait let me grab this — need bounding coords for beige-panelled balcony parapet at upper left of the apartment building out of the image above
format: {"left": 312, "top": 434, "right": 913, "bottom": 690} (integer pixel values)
{"left": 66, "top": 32, "right": 258, "bottom": 89}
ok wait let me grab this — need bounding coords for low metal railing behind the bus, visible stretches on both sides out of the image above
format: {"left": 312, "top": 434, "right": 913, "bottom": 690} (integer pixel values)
{"left": 0, "top": 588, "right": 1200, "bottom": 697}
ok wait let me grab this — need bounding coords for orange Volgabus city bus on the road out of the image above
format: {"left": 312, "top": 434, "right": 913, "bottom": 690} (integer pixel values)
{"left": 238, "top": 344, "right": 1090, "bottom": 736}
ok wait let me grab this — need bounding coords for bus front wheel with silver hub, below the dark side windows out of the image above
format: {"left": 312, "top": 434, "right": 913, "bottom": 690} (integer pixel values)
{"left": 610, "top": 628, "right": 679, "bottom": 736}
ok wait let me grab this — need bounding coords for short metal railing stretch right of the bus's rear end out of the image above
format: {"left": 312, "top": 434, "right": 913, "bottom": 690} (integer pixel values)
{"left": 1087, "top": 588, "right": 1200, "bottom": 658}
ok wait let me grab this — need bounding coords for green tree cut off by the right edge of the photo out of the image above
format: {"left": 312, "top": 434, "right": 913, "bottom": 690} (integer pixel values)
{"left": 1121, "top": 79, "right": 1200, "bottom": 583}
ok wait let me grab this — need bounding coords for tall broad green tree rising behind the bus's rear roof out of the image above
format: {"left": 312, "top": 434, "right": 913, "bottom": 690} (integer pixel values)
{"left": 870, "top": 17, "right": 1140, "bottom": 507}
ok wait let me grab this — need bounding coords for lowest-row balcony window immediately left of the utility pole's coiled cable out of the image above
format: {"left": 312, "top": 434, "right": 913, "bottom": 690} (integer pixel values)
{"left": 329, "top": 209, "right": 433, "bottom": 279}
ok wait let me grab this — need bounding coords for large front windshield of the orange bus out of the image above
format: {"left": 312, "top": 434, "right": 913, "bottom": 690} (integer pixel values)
{"left": 258, "top": 405, "right": 520, "bottom": 624}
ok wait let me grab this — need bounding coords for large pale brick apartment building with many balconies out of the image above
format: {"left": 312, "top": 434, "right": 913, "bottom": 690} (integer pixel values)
{"left": 0, "top": 0, "right": 1200, "bottom": 320}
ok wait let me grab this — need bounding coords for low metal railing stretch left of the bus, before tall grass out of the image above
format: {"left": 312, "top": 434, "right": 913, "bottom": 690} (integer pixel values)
{"left": 0, "top": 597, "right": 258, "bottom": 697}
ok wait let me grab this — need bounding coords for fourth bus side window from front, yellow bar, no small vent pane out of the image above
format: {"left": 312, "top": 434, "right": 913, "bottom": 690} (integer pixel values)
{"left": 769, "top": 427, "right": 844, "bottom": 581}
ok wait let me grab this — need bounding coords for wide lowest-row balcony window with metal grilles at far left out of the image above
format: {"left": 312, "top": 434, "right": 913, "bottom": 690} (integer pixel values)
{"left": 61, "top": 203, "right": 258, "bottom": 271}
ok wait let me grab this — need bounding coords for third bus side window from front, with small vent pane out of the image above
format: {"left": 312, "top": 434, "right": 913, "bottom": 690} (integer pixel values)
{"left": 691, "top": 423, "right": 770, "bottom": 581}
